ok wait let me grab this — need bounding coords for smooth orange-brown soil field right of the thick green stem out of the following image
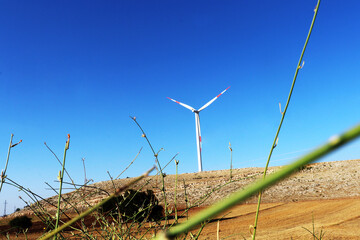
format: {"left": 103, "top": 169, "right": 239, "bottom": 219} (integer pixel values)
{"left": 187, "top": 198, "right": 360, "bottom": 239}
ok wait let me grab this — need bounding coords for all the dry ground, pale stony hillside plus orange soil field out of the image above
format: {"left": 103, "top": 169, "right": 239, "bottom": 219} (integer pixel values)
{"left": 0, "top": 160, "right": 360, "bottom": 239}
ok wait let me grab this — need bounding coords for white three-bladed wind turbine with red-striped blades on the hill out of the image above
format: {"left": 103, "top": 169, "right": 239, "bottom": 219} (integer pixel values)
{"left": 168, "top": 87, "right": 230, "bottom": 172}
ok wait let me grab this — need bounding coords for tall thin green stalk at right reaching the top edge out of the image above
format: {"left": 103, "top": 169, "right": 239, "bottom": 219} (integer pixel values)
{"left": 252, "top": 0, "right": 320, "bottom": 240}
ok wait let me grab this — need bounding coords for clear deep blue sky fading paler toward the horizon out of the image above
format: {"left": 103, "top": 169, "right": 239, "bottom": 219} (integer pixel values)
{"left": 0, "top": 0, "right": 360, "bottom": 215}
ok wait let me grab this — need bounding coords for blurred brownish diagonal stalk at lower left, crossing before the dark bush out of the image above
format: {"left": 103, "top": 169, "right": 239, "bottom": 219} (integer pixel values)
{"left": 40, "top": 167, "right": 155, "bottom": 240}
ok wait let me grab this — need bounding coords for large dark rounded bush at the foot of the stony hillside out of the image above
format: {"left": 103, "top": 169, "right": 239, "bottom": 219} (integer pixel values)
{"left": 100, "top": 189, "right": 163, "bottom": 222}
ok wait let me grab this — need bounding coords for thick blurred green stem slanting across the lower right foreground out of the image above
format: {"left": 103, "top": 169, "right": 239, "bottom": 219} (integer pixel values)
{"left": 156, "top": 124, "right": 360, "bottom": 239}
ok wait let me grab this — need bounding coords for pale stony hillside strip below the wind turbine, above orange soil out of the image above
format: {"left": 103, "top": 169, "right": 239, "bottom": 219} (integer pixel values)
{"left": 16, "top": 160, "right": 360, "bottom": 214}
